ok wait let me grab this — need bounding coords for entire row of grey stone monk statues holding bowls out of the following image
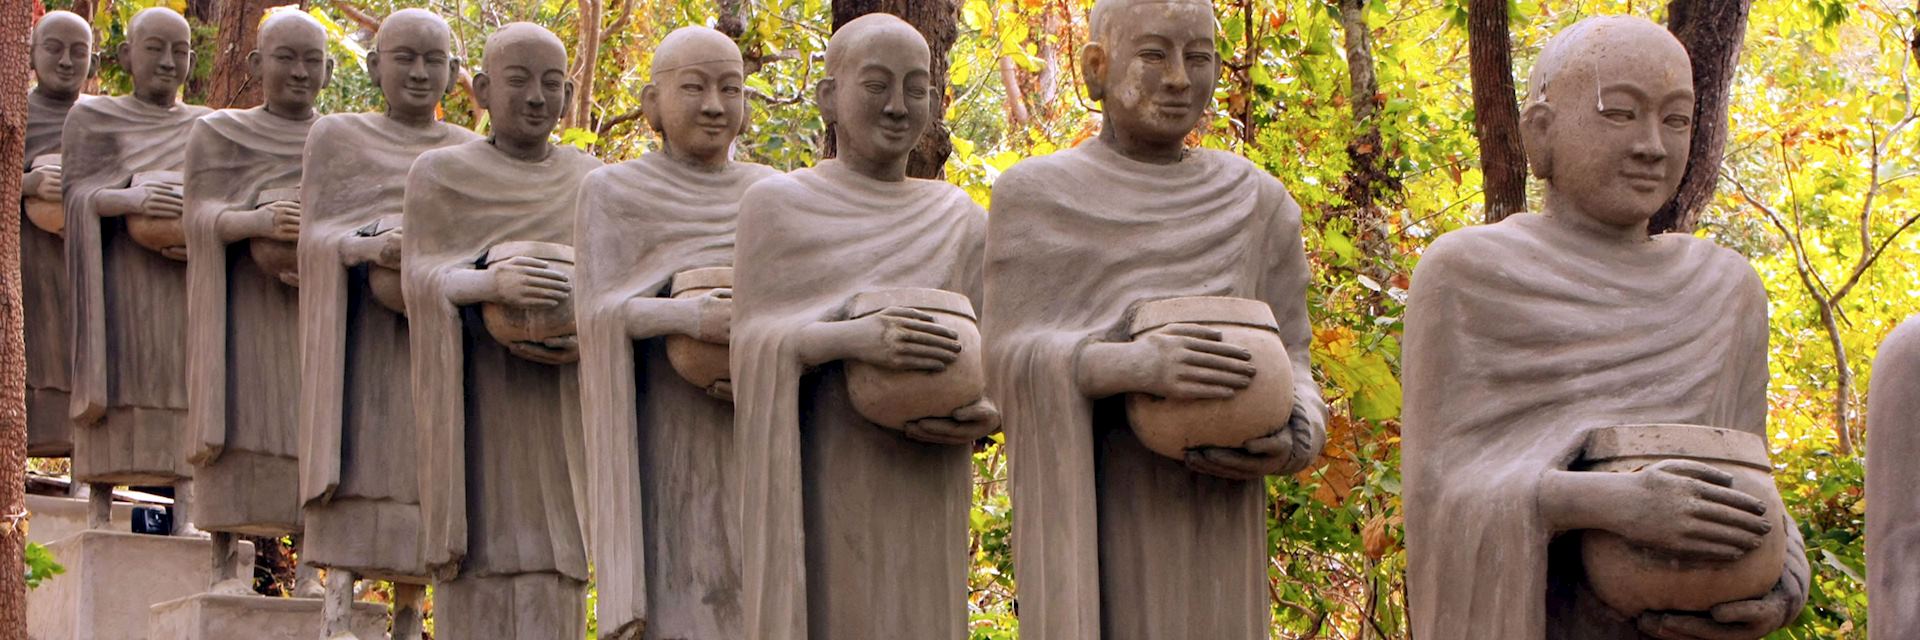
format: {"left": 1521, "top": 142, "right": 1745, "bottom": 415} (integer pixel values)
{"left": 23, "top": 0, "right": 1920, "bottom": 640}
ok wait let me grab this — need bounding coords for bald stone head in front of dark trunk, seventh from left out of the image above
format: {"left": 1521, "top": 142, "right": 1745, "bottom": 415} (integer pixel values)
{"left": 818, "top": 13, "right": 935, "bottom": 181}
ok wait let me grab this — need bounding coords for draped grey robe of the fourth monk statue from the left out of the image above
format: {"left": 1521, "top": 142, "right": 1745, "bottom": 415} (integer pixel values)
{"left": 298, "top": 113, "right": 480, "bottom": 582}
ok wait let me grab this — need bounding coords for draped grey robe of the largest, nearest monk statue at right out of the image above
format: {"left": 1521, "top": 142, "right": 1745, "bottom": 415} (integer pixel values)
{"left": 1402, "top": 213, "right": 1809, "bottom": 640}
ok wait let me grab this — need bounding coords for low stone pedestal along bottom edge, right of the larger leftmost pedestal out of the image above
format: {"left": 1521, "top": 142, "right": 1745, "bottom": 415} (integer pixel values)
{"left": 148, "top": 594, "right": 386, "bottom": 640}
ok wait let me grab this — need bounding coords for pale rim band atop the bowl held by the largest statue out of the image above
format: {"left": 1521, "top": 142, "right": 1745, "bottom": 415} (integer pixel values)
{"left": 1580, "top": 425, "right": 1774, "bottom": 471}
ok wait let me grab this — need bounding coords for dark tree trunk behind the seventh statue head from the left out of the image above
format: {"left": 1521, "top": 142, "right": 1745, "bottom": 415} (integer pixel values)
{"left": 820, "top": 0, "right": 960, "bottom": 179}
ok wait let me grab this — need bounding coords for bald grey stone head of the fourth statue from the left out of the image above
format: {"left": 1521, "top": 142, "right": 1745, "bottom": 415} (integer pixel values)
{"left": 367, "top": 10, "right": 461, "bottom": 123}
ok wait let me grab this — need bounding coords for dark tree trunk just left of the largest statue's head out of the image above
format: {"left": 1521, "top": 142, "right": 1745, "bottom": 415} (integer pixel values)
{"left": 1467, "top": 0, "right": 1526, "bottom": 223}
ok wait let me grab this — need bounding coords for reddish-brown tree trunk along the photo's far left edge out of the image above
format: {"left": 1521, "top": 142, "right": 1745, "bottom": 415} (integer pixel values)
{"left": 0, "top": 2, "right": 33, "bottom": 638}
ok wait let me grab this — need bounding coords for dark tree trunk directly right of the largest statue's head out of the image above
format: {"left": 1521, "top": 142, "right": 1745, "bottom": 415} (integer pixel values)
{"left": 1647, "top": 0, "right": 1753, "bottom": 233}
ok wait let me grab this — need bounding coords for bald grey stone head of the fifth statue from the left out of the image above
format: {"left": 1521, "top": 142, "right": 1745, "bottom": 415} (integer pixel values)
{"left": 474, "top": 23, "right": 574, "bottom": 148}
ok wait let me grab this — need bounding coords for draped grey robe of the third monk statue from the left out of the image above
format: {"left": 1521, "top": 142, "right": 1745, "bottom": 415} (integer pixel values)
{"left": 186, "top": 108, "right": 317, "bottom": 536}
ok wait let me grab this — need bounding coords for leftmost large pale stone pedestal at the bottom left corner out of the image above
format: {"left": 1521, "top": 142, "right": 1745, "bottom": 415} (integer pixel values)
{"left": 27, "top": 530, "right": 253, "bottom": 640}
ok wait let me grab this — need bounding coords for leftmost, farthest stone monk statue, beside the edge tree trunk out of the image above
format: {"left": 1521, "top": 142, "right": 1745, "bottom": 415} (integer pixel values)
{"left": 19, "top": 12, "right": 94, "bottom": 457}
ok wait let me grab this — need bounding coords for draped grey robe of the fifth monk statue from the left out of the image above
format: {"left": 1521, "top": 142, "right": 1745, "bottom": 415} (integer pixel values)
{"left": 401, "top": 140, "right": 601, "bottom": 638}
